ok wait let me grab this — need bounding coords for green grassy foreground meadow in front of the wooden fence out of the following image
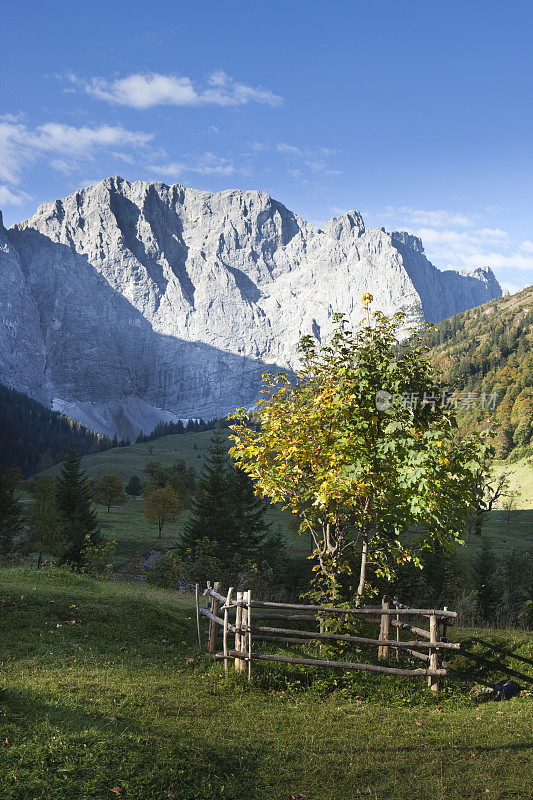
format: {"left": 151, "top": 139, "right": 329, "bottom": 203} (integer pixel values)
{"left": 0, "top": 569, "right": 532, "bottom": 800}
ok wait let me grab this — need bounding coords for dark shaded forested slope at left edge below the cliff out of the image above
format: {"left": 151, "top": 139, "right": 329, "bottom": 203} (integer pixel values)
{"left": 0, "top": 384, "right": 117, "bottom": 477}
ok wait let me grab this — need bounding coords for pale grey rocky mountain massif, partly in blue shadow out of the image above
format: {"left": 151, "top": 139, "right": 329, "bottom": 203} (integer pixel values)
{"left": 0, "top": 178, "right": 501, "bottom": 436}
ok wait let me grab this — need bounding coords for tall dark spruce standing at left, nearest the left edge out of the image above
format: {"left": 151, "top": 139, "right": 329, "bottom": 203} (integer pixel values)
{"left": 56, "top": 446, "right": 101, "bottom": 570}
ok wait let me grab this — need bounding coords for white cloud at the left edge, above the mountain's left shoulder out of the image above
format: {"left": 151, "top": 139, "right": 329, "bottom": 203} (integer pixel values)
{"left": 0, "top": 121, "right": 153, "bottom": 184}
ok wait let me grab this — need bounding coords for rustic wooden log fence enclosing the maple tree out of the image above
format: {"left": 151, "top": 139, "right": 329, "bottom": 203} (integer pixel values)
{"left": 196, "top": 582, "right": 459, "bottom": 691}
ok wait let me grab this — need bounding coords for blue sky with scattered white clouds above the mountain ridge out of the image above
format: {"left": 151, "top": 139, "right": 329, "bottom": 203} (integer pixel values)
{"left": 0, "top": 0, "right": 533, "bottom": 291}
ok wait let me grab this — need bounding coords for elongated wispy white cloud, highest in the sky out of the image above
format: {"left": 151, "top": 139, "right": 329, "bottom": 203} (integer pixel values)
{"left": 67, "top": 71, "right": 283, "bottom": 110}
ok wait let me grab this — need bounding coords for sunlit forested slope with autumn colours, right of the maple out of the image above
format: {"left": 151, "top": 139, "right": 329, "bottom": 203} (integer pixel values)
{"left": 429, "top": 286, "right": 533, "bottom": 459}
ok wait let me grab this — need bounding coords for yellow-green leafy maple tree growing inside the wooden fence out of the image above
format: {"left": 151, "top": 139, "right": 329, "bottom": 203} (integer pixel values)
{"left": 230, "top": 294, "right": 490, "bottom": 600}
